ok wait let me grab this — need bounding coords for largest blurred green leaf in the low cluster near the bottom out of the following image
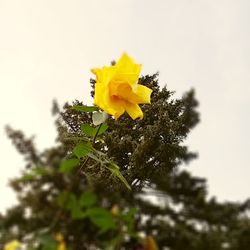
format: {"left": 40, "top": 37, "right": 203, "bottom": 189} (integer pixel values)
{"left": 86, "top": 207, "right": 116, "bottom": 231}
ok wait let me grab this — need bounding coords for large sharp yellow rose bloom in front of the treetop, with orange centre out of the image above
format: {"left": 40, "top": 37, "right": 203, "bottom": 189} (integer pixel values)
{"left": 92, "top": 53, "right": 152, "bottom": 119}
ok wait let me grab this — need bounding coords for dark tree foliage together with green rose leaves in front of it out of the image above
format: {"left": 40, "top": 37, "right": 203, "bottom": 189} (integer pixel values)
{"left": 0, "top": 75, "right": 250, "bottom": 250}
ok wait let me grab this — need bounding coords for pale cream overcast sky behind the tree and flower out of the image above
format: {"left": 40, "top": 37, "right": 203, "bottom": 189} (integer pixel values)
{"left": 0, "top": 0, "right": 250, "bottom": 211}
